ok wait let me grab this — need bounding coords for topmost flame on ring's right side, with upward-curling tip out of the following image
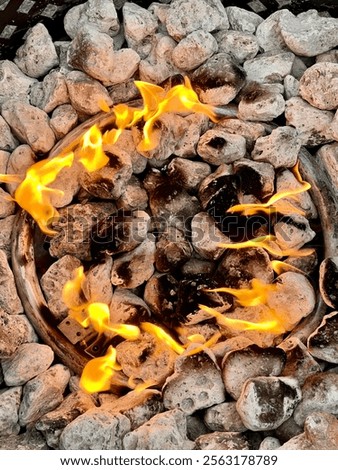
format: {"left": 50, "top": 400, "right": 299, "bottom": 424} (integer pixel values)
{"left": 227, "top": 163, "right": 311, "bottom": 216}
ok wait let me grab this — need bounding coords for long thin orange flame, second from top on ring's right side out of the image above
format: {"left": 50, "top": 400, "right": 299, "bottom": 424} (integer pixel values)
{"left": 219, "top": 235, "right": 314, "bottom": 256}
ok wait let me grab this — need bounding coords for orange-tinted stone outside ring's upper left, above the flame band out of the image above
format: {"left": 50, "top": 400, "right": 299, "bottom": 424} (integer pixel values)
{"left": 66, "top": 70, "right": 113, "bottom": 115}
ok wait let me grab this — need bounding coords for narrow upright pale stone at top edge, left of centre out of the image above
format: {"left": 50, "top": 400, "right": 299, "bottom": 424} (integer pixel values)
{"left": 122, "top": 2, "right": 158, "bottom": 59}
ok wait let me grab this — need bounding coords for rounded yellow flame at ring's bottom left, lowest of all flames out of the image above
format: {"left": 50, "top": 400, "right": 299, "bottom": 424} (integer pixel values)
{"left": 80, "top": 346, "right": 120, "bottom": 393}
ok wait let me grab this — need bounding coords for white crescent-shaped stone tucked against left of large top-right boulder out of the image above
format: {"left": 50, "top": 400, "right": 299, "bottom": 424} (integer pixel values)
{"left": 256, "top": 9, "right": 289, "bottom": 52}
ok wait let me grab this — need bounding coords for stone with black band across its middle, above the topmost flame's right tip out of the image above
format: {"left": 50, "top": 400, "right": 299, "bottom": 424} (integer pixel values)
{"left": 191, "top": 52, "right": 245, "bottom": 106}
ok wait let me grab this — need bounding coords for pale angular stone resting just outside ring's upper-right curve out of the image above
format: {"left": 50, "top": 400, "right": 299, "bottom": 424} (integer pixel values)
{"left": 251, "top": 126, "right": 302, "bottom": 168}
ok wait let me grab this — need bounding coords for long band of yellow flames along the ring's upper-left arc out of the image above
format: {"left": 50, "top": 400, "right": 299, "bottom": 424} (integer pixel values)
{"left": 0, "top": 77, "right": 216, "bottom": 236}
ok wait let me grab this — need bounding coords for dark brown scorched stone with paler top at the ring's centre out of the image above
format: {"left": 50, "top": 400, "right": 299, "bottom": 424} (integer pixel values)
{"left": 155, "top": 227, "right": 192, "bottom": 273}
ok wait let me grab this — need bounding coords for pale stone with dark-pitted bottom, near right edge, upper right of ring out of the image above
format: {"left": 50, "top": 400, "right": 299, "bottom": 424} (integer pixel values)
{"left": 285, "top": 97, "right": 333, "bottom": 147}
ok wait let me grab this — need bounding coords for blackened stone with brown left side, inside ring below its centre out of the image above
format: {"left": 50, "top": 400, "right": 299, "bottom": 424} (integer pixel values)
{"left": 144, "top": 274, "right": 180, "bottom": 326}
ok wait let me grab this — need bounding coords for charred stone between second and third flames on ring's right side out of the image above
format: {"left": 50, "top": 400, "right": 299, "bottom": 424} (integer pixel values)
{"left": 218, "top": 248, "right": 274, "bottom": 289}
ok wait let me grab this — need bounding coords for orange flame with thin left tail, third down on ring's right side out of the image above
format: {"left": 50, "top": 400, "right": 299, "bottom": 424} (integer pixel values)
{"left": 207, "top": 278, "right": 277, "bottom": 307}
